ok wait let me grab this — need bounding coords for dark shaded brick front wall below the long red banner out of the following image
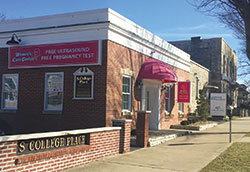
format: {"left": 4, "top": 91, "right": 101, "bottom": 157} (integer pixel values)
{"left": 0, "top": 41, "right": 107, "bottom": 134}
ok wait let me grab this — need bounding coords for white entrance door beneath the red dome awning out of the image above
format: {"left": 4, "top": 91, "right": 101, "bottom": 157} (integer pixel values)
{"left": 145, "top": 86, "right": 160, "bottom": 130}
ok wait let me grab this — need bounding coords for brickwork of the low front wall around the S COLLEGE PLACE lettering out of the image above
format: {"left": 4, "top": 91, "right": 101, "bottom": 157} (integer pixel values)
{"left": 0, "top": 129, "right": 120, "bottom": 172}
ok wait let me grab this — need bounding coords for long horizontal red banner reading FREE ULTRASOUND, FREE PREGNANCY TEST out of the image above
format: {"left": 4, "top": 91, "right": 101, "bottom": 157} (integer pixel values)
{"left": 8, "top": 40, "right": 100, "bottom": 69}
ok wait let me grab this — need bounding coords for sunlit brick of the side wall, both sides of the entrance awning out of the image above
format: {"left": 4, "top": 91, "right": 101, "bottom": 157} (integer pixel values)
{"left": 106, "top": 41, "right": 189, "bottom": 129}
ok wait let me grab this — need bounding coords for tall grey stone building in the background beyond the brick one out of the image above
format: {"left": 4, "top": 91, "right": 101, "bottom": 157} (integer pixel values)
{"left": 170, "top": 37, "right": 237, "bottom": 107}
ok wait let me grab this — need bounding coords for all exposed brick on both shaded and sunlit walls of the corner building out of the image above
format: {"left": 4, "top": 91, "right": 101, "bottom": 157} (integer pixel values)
{"left": 0, "top": 40, "right": 189, "bottom": 134}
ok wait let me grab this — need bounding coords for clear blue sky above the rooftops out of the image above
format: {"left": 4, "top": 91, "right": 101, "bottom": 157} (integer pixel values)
{"left": 0, "top": 0, "right": 244, "bottom": 74}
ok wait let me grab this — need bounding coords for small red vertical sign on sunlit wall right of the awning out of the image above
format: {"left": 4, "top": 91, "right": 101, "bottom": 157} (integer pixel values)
{"left": 178, "top": 82, "right": 190, "bottom": 103}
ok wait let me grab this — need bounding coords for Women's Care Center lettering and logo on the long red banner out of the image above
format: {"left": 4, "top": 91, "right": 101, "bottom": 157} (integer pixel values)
{"left": 11, "top": 48, "right": 40, "bottom": 63}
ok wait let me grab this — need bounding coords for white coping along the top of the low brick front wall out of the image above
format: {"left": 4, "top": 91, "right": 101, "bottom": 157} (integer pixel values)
{"left": 0, "top": 127, "right": 121, "bottom": 143}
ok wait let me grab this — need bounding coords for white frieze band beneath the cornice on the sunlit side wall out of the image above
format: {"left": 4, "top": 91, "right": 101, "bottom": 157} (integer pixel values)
{"left": 108, "top": 23, "right": 190, "bottom": 72}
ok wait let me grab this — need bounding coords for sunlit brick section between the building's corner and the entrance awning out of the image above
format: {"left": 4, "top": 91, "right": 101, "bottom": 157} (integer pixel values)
{"left": 106, "top": 41, "right": 148, "bottom": 128}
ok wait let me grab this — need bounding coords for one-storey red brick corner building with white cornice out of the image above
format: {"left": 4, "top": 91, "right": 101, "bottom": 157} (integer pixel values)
{"left": 0, "top": 9, "right": 190, "bottom": 134}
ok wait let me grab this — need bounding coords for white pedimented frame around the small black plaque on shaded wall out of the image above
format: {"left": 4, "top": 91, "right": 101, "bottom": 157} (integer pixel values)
{"left": 73, "top": 67, "right": 95, "bottom": 100}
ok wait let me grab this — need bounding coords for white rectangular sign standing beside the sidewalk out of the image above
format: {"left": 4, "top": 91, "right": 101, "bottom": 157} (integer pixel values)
{"left": 210, "top": 93, "right": 227, "bottom": 116}
